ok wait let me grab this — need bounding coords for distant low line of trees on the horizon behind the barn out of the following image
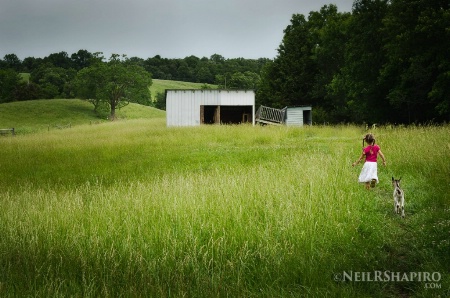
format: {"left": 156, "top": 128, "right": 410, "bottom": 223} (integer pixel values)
{"left": 0, "top": 50, "right": 270, "bottom": 105}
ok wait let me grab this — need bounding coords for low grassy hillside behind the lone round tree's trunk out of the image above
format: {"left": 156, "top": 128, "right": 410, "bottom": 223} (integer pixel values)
{"left": 0, "top": 99, "right": 166, "bottom": 134}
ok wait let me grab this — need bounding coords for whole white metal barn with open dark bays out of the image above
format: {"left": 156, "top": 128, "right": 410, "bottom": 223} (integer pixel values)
{"left": 166, "top": 89, "right": 255, "bottom": 126}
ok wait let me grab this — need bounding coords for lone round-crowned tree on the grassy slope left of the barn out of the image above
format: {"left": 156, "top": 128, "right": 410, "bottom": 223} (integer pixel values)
{"left": 74, "top": 54, "right": 152, "bottom": 120}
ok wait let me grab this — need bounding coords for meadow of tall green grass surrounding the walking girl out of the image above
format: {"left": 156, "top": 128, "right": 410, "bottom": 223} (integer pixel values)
{"left": 0, "top": 100, "right": 450, "bottom": 297}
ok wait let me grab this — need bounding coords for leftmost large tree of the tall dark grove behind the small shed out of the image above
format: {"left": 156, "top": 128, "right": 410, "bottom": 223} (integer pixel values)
{"left": 256, "top": 5, "right": 350, "bottom": 116}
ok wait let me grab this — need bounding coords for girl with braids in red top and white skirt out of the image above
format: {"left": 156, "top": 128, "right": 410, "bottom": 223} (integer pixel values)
{"left": 352, "top": 133, "right": 386, "bottom": 189}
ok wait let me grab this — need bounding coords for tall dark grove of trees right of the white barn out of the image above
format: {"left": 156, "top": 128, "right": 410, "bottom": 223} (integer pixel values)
{"left": 257, "top": 0, "right": 450, "bottom": 123}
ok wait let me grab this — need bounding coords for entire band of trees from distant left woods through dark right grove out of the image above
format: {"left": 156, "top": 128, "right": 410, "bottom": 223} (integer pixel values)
{"left": 0, "top": 0, "right": 450, "bottom": 123}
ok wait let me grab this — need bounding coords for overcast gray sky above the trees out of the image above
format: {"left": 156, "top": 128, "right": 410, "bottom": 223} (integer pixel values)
{"left": 0, "top": 0, "right": 353, "bottom": 59}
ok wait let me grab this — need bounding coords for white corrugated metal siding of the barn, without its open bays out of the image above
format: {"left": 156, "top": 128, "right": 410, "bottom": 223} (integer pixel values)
{"left": 166, "top": 90, "right": 255, "bottom": 126}
